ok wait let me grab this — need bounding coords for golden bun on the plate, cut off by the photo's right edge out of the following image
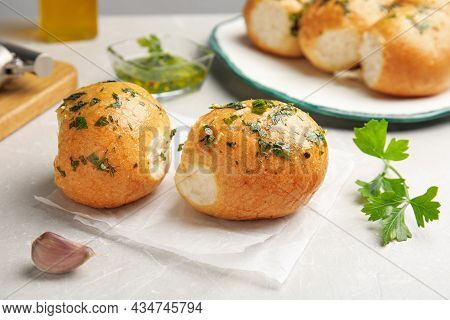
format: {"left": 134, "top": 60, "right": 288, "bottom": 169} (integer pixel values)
{"left": 361, "top": 1, "right": 450, "bottom": 97}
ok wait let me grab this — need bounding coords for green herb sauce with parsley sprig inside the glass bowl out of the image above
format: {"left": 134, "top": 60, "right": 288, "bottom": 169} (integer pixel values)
{"left": 114, "top": 35, "right": 208, "bottom": 93}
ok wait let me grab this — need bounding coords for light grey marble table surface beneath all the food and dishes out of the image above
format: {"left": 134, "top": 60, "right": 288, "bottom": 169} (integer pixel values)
{"left": 0, "top": 15, "right": 450, "bottom": 299}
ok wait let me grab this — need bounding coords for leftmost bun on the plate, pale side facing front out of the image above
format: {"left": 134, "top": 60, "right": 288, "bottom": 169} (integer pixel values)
{"left": 244, "top": 0, "right": 307, "bottom": 58}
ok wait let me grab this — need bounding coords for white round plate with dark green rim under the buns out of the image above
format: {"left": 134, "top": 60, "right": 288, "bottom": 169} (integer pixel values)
{"left": 209, "top": 17, "right": 450, "bottom": 122}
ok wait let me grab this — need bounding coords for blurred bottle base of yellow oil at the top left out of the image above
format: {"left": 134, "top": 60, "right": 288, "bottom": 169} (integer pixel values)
{"left": 39, "top": 0, "right": 97, "bottom": 41}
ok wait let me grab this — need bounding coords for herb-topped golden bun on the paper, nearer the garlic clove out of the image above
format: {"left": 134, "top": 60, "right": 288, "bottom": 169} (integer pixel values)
{"left": 54, "top": 82, "right": 170, "bottom": 208}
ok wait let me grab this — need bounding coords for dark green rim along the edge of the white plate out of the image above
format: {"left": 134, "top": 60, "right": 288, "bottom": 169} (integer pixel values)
{"left": 208, "top": 15, "right": 450, "bottom": 123}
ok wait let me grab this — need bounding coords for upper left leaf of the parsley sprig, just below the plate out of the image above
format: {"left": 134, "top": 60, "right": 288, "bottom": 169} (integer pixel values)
{"left": 353, "top": 119, "right": 388, "bottom": 159}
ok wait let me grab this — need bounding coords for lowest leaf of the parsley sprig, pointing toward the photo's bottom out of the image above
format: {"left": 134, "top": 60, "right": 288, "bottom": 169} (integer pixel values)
{"left": 382, "top": 206, "right": 411, "bottom": 245}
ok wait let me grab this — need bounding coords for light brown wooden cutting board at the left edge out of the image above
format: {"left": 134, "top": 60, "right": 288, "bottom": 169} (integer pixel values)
{"left": 0, "top": 61, "right": 77, "bottom": 140}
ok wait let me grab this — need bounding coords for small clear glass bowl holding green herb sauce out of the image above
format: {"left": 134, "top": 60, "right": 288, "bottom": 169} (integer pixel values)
{"left": 107, "top": 34, "right": 214, "bottom": 98}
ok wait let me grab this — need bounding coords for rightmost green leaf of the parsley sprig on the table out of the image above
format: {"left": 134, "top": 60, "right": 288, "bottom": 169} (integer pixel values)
{"left": 410, "top": 187, "right": 441, "bottom": 228}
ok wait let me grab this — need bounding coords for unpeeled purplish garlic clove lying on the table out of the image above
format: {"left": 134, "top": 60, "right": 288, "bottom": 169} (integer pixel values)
{"left": 31, "top": 232, "right": 94, "bottom": 273}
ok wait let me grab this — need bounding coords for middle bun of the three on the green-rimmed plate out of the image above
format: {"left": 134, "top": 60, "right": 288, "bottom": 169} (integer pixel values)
{"left": 298, "top": 0, "right": 392, "bottom": 72}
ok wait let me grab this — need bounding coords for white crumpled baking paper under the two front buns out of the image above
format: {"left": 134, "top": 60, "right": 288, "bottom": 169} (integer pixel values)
{"left": 35, "top": 114, "right": 354, "bottom": 283}
